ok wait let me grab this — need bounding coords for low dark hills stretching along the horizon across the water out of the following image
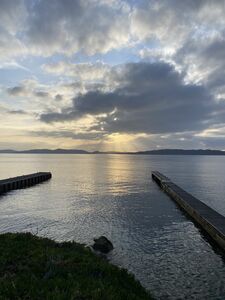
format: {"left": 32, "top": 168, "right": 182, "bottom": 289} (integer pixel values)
{"left": 0, "top": 149, "right": 225, "bottom": 155}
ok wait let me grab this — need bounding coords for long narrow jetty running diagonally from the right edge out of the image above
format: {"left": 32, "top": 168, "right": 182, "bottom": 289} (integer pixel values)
{"left": 152, "top": 171, "right": 225, "bottom": 250}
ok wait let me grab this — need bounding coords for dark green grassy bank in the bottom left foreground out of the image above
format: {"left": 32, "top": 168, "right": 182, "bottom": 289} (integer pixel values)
{"left": 0, "top": 233, "right": 152, "bottom": 300}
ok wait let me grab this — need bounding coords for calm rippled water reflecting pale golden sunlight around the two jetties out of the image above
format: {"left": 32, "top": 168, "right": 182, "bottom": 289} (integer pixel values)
{"left": 0, "top": 154, "right": 225, "bottom": 300}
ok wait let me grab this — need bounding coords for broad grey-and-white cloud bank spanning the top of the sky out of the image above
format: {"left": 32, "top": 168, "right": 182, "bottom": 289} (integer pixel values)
{"left": 0, "top": 0, "right": 225, "bottom": 62}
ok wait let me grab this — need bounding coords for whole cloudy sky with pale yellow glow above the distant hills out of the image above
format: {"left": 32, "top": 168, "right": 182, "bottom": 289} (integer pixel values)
{"left": 0, "top": 0, "right": 225, "bottom": 151}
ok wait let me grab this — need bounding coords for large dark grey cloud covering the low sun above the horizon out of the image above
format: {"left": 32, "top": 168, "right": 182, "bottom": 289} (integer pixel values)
{"left": 40, "top": 63, "right": 221, "bottom": 133}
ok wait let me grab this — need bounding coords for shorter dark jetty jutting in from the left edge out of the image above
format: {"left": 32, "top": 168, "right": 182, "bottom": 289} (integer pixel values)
{"left": 0, "top": 172, "right": 52, "bottom": 194}
